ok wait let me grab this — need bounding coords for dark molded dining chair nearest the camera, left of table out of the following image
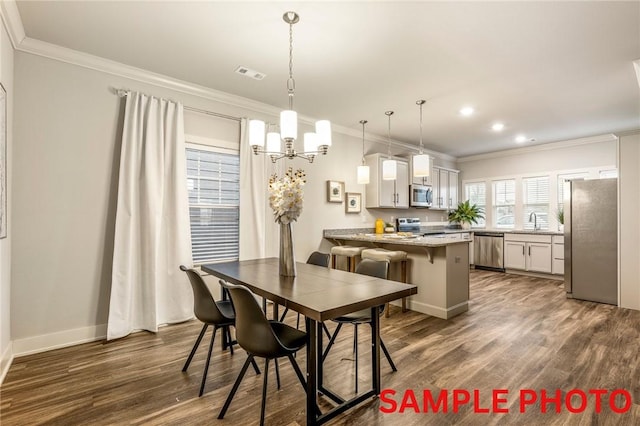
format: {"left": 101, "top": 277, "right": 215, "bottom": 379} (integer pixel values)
{"left": 218, "top": 282, "right": 317, "bottom": 426}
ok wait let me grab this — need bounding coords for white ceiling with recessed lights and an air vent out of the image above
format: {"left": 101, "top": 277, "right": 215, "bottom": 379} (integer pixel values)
{"left": 12, "top": 0, "right": 640, "bottom": 157}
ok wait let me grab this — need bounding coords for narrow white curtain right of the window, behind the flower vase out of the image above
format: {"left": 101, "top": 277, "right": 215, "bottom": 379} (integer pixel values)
{"left": 240, "top": 118, "right": 271, "bottom": 260}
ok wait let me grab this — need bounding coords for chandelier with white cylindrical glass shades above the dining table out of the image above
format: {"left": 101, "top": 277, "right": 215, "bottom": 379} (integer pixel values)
{"left": 249, "top": 12, "right": 331, "bottom": 163}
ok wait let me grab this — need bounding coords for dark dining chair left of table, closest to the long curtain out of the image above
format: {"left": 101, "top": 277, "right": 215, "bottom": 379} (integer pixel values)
{"left": 180, "top": 265, "right": 260, "bottom": 396}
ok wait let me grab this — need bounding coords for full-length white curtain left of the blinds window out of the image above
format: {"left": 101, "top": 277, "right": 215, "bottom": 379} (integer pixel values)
{"left": 107, "top": 92, "right": 193, "bottom": 340}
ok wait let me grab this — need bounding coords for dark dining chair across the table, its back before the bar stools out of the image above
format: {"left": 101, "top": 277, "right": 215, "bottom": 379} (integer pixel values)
{"left": 322, "top": 259, "right": 398, "bottom": 393}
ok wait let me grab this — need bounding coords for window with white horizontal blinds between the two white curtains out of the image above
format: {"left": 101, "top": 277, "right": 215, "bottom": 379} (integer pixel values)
{"left": 186, "top": 147, "right": 240, "bottom": 265}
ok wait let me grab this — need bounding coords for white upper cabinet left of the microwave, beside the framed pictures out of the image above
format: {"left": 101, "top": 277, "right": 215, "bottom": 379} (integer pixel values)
{"left": 365, "top": 154, "right": 409, "bottom": 209}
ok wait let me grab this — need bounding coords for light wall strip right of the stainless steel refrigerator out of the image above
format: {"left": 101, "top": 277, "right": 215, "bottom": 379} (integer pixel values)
{"left": 619, "top": 133, "right": 640, "bottom": 310}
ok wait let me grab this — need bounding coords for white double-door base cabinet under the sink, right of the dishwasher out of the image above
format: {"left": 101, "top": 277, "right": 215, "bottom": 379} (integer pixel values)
{"left": 504, "top": 234, "right": 551, "bottom": 274}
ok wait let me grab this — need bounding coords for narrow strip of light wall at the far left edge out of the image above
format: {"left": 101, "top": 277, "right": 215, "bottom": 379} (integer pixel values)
{"left": 0, "top": 10, "right": 14, "bottom": 383}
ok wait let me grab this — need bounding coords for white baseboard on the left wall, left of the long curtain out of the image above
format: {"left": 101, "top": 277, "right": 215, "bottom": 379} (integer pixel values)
{"left": 13, "top": 324, "right": 107, "bottom": 358}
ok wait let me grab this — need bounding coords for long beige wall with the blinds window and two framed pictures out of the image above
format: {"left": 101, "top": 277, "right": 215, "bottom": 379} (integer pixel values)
{"left": 11, "top": 52, "right": 450, "bottom": 354}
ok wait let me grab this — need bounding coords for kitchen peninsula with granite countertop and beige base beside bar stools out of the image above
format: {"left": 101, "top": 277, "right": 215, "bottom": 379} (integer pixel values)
{"left": 323, "top": 229, "right": 471, "bottom": 319}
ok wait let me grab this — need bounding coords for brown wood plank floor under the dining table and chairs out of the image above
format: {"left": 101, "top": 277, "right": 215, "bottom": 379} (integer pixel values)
{"left": 0, "top": 271, "right": 640, "bottom": 426}
